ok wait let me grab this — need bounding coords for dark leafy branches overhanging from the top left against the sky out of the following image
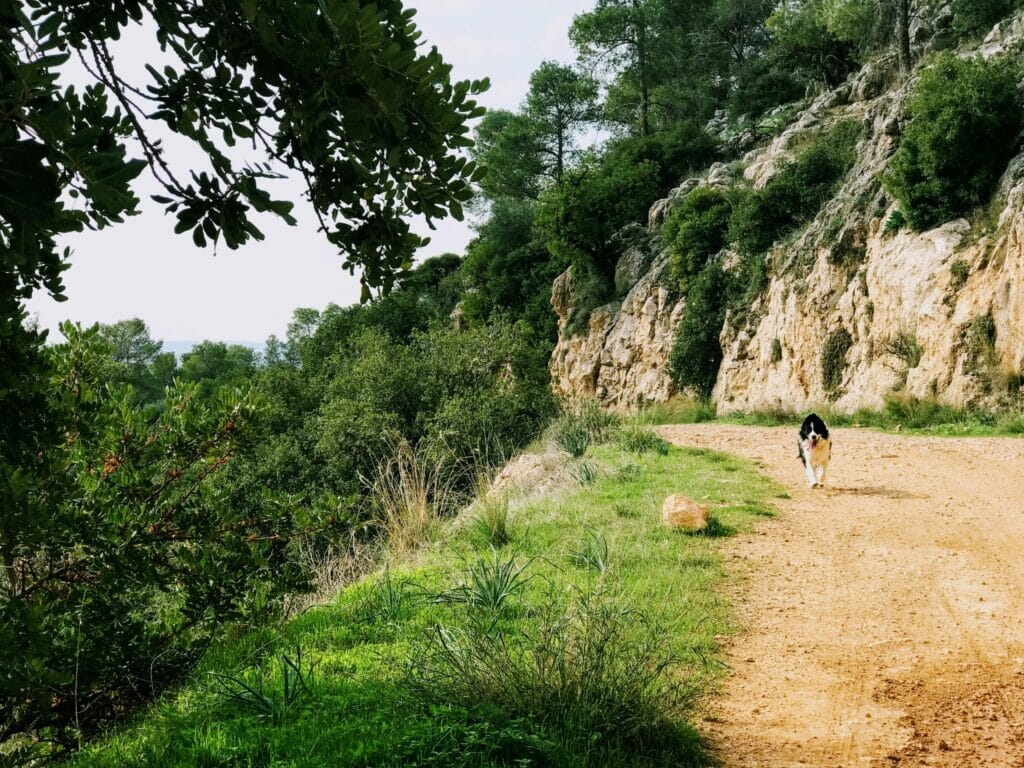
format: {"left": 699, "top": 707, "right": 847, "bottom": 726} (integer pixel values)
{"left": 0, "top": 0, "right": 486, "bottom": 313}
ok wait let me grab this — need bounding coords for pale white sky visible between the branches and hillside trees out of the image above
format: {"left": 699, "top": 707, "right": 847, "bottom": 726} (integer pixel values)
{"left": 29, "top": 0, "right": 594, "bottom": 342}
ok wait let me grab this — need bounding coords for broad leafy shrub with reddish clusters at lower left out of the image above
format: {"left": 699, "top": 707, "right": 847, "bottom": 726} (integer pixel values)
{"left": 0, "top": 324, "right": 308, "bottom": 756}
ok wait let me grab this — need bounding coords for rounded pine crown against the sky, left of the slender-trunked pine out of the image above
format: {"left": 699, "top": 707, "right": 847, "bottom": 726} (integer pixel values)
{"left": 471, "top": 110, "right": 544, "bottom": 201}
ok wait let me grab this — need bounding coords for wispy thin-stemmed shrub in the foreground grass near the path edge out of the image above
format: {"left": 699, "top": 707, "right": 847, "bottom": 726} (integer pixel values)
{"left": 402, "top": 597, "right": 694, "bottom": 765}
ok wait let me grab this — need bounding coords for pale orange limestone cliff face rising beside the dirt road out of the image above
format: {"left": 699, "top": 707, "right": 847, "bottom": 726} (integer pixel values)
{"left": 551, "top": 17, "right": 1024, "bottom": 412}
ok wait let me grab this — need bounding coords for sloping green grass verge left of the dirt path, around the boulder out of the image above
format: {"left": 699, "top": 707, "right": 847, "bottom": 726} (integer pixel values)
{"left": 73, "top": 440, "right": 779, "bottom": 767}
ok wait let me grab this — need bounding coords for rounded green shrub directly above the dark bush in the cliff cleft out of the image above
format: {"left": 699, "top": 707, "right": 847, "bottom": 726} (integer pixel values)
{"left": 662, "top": 187, "right": 732, "bottom": 295}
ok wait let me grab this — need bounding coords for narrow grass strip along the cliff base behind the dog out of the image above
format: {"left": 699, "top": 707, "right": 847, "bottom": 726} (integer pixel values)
{"left": 639, "top": 397, "right": 1024, "bottom": 437}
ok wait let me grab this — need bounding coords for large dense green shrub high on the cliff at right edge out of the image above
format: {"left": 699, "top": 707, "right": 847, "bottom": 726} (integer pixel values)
{"left": 883, "top": 53, "right": 1021, "bottom": 229}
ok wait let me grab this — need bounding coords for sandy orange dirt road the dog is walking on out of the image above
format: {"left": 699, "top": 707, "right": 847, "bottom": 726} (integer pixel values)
{"left": 660, "top": 424, "right": 1024, "bottom": 768}
